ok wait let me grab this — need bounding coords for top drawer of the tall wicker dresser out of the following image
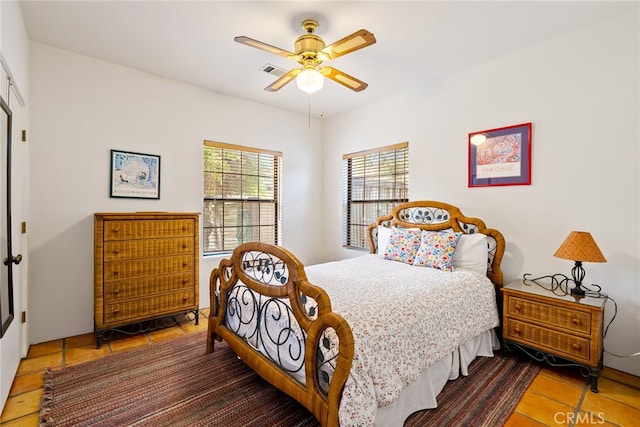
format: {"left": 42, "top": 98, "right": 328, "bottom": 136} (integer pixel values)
{"left": 103, "top": 219, "right": 196, "bottom": 242}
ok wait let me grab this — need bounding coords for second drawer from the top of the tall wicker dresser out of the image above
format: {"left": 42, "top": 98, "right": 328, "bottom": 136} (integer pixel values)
{"left": 104, "top": 237, "right": 195, "bottom": 262}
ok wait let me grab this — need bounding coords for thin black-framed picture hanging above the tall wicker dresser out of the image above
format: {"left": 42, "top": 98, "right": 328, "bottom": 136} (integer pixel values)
{"left": 109, "top": 150, "right": 160, "bottom": 199}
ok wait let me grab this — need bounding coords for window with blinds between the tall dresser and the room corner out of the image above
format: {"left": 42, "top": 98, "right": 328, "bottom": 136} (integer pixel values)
{"left": 203, "top": 141, "right": 282, "bottom": 254}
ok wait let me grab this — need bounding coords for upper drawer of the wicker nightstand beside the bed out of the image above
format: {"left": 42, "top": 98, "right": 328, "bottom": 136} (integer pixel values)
{"left": 506, "top": 295, "right": 591, "bottom": 335}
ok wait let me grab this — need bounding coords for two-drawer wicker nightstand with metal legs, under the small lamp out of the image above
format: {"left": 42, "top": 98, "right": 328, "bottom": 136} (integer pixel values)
{"left": 502, "top": 280, "right": 606, "bottom": 393}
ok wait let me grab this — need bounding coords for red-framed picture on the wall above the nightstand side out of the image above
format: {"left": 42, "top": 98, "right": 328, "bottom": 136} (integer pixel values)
{"left": 467, "top": 123, "right": 531, "bottom": 187}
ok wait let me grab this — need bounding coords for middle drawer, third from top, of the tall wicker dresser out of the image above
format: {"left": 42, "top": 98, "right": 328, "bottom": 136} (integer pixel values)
{"left": 103, "top": 256, "right": 195, "bottom": 282}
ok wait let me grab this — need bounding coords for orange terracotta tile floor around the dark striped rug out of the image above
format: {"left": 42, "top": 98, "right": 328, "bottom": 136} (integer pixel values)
{"left": 0, "top": 311, "right": 640, "bottom": 427}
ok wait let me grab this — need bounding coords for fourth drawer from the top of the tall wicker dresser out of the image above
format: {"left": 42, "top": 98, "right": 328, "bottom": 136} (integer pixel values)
{"left": 104, "top": 272, "right": 195, "bottom": 304}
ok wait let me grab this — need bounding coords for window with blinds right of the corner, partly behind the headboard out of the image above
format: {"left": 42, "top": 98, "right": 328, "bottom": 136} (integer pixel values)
{"left": 342, "top": 142, "right": 409, "bottom": 249}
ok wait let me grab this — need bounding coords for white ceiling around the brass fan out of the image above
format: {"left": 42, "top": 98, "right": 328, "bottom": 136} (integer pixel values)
{"left": 17, "top": 0, "right": 638, "bottom": 117}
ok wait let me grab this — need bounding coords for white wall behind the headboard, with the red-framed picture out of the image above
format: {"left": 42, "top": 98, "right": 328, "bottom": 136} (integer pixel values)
{"left": 324, "top": 11, "right": 640, "bottom": 375}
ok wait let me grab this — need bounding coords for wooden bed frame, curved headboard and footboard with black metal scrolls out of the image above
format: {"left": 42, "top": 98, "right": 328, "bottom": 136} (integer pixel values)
{"left": 206, "top": 201, "right": 505, "bottom": 426}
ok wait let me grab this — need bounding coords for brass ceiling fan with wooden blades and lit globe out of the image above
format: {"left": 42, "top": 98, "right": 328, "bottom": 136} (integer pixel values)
{"left": 233, "top": 19, "right": 376, "bottom": 93}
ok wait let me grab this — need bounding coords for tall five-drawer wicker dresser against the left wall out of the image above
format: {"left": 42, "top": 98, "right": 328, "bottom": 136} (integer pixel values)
{"left": 94, "top": 212, "right": 200, "bottom": 347}
